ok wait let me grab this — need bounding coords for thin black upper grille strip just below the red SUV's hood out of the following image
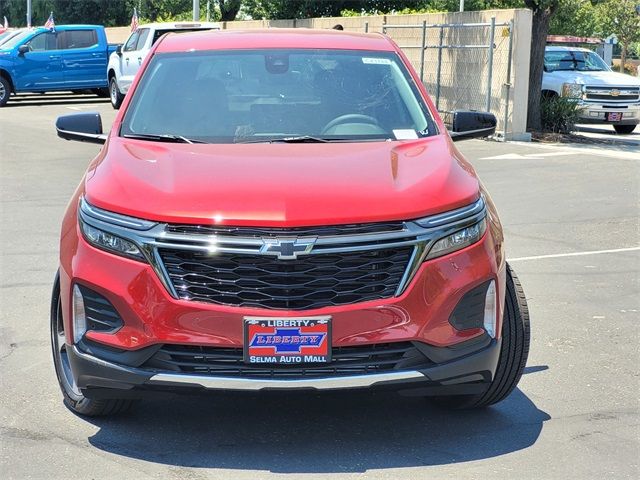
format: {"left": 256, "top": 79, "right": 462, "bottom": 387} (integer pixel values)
{"left": 166, "top": 222, "right": 404, "bottom": 238}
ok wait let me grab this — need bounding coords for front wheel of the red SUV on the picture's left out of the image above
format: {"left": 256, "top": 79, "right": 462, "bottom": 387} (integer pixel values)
{"left": 51, "top": 274, "right": 133, "bottom": 417}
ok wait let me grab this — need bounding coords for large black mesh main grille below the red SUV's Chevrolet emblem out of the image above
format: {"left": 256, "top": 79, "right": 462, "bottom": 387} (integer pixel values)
{"left": 158, "top": 246, "right": 413, "bottom": 310}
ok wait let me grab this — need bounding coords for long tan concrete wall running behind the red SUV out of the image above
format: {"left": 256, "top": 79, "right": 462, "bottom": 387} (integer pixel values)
{"left": 107, "top": 9, "right": 532, "bottom": 138}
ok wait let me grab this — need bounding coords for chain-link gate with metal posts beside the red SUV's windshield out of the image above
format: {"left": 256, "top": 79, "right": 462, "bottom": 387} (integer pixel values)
{"left": 380, "top": 17, "right": 513, "bottom": 138}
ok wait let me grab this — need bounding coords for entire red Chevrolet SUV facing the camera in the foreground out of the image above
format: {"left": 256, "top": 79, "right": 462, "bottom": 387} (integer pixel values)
{"left": 51, "top": 29, "right": 529, "bottom": 415}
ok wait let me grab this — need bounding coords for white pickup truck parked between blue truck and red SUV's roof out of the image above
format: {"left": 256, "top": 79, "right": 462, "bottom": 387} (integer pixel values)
{"left": 107, "top": 22, "right": 220, "bottom": 109}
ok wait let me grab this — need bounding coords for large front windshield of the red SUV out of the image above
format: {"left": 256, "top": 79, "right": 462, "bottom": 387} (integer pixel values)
{"left": 120, "top": 49, "right": 435, "bottom": 143}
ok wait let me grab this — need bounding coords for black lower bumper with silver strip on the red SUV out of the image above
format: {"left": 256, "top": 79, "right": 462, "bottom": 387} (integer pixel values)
{"left": 68, "top": 337, "right": 500, "bottom": 398}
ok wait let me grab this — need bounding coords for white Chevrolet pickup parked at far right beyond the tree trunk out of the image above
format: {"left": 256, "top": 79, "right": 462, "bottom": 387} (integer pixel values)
{"left": 542, "top": 47, "right": 640, "bottom": 133}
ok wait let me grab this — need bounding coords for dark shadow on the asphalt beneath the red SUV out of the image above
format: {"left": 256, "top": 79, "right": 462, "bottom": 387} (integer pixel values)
{"left": 82, "top": 374, "right": 550, "bottom": 474}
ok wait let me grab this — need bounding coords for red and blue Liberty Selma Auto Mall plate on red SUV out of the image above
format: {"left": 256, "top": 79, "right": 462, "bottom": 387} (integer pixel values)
{"left": 242, "top": 315, "right": 332, "bottom": 367}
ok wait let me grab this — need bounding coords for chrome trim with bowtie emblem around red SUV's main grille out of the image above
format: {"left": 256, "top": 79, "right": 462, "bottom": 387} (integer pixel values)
{"left": 78, "top": 197, "right": 486, "bottom": 306}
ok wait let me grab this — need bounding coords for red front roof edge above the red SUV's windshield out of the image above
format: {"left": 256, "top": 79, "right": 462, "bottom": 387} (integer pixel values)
{"left": 157, "top": 28, "right": 395, "bottom": 53}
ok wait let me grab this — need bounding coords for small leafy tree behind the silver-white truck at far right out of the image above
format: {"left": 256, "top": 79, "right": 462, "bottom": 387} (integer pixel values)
{"left": 601, "top": 0, "right": 640, "bottom": 72}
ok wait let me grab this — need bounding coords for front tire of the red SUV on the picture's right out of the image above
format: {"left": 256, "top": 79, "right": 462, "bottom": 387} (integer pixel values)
{"left": 433, "top": 264, "right": 530, "bottom": 409}
